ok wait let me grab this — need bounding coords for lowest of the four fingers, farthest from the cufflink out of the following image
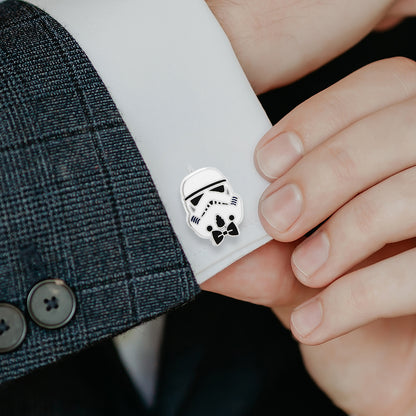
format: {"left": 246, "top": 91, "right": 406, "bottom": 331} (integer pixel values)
{"left": 291, "top": 249, "right": 416, "bottom": 345}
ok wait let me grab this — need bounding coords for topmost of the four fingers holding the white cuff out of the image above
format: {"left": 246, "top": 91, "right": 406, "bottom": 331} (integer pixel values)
{"left": 255, "top": 58, "right": 416, "bottom": 180}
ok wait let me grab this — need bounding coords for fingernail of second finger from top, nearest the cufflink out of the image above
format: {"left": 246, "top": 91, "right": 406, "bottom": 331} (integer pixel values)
{"left": 260, "top": 184, "right": 303, "bottom": 233}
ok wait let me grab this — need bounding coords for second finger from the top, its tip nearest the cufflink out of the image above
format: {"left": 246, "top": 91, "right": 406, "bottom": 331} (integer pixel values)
{"left": 259, "top": 93, "right": 416, "bottom": 241}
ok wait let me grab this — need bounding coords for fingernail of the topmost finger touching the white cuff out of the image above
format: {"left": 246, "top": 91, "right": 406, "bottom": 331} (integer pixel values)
{"left": 257, "top": 132, "right": 303, "bottom": 179}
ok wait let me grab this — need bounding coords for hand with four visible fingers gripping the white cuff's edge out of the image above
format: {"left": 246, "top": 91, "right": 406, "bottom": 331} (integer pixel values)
{"left": 256, "top": 58, "right": 416, "bottom": 416}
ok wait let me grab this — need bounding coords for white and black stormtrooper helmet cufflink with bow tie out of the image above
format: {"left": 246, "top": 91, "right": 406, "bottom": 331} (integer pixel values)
{"left": 181, "top": 168, "right": 243, "bottom": 246}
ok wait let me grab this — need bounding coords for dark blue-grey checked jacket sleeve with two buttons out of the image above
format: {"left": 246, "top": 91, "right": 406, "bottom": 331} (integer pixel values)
{"left": 0, "top": 0, "right": 199, "bottom": 382}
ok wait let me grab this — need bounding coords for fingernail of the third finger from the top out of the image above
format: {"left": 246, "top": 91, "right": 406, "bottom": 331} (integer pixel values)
{"left": 292, "top": 231, "right": 329, "bottom": 277}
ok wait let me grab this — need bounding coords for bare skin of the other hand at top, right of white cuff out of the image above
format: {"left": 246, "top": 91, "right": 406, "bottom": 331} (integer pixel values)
{"left": 206, "top": 0, "right": 416, "bottom": 93}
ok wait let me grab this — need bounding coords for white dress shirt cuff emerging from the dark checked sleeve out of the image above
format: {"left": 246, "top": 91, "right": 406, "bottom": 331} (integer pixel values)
{"left": 29, "top": 0, "right": 270, "bottom": 283}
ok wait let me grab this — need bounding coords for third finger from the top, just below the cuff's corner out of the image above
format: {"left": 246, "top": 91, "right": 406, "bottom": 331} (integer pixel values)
{"left": 292, "top": 167, "right": 416, "bottom": 287}
